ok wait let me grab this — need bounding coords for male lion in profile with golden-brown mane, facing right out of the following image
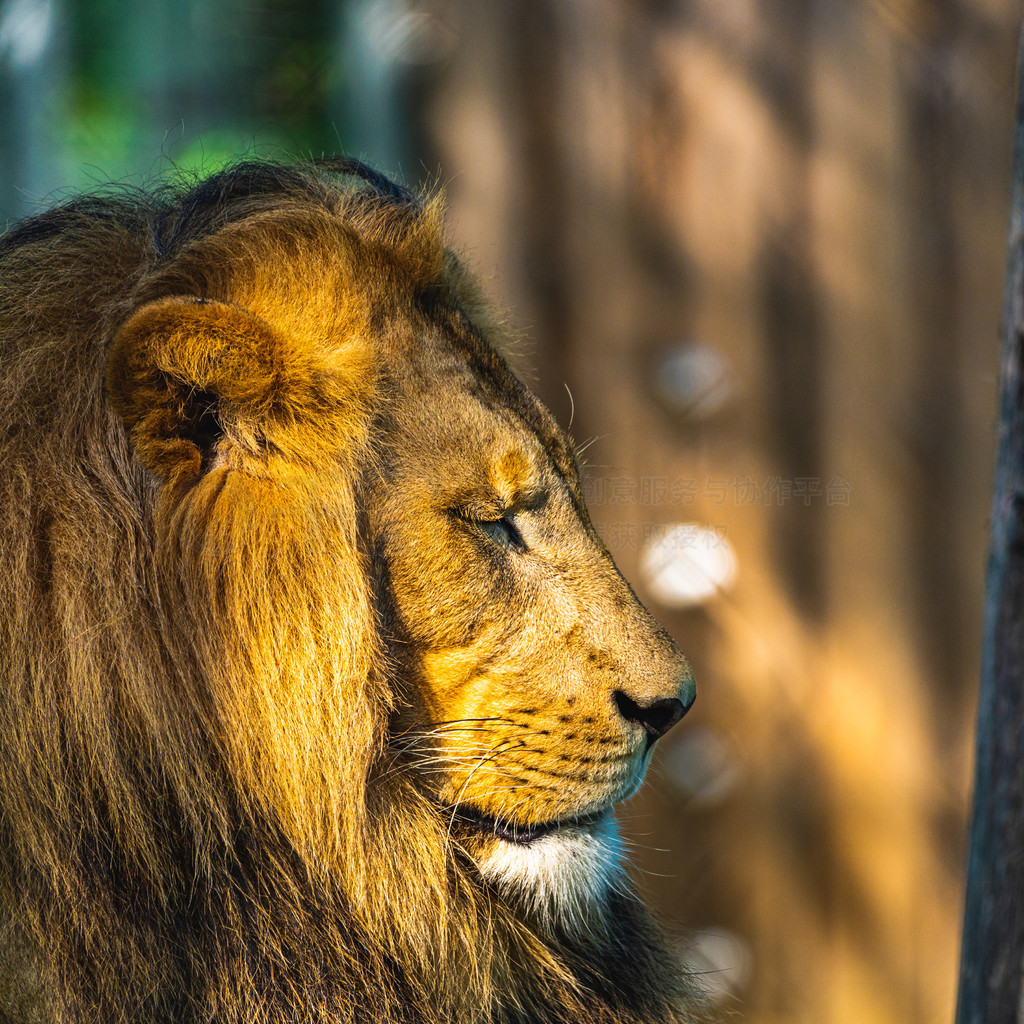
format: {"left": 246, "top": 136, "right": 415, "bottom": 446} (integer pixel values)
{"left": 0, "top": 159, "right": 699, "bottom": 1024}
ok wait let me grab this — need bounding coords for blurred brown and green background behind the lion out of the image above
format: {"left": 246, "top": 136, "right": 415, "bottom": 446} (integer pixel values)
{"left": 0, "top": 0, "right": 1021, "bottom": 1024}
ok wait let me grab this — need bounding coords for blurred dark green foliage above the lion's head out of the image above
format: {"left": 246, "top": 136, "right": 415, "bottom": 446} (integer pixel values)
{"left": 64, "top": 0, "right": 345, "bottom": 187}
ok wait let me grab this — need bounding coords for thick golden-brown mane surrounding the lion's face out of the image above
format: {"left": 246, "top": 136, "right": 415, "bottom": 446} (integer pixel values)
{"left": 0, "top": 162, "right": 700, "bottom": 1024}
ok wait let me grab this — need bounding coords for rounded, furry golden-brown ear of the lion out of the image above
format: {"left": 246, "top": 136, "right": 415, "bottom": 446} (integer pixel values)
{"left": 106, "top": 297, "right": 365, "bottom": 479}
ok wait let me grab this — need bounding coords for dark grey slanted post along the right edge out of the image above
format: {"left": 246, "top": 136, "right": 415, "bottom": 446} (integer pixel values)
{"left": 956, "top": 22, "right": 1024, "bottom": 1024}
